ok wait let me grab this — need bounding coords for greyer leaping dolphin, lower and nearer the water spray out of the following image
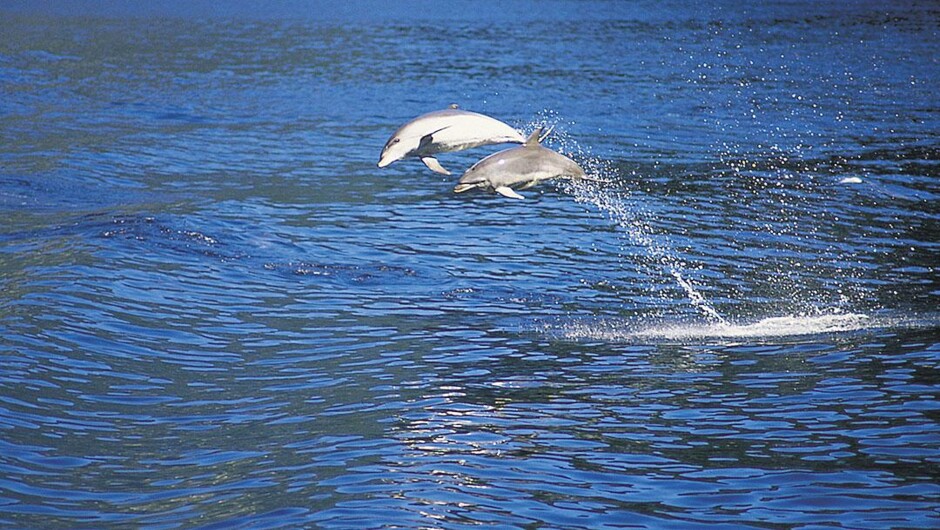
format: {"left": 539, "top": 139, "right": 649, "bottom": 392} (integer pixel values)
{"left": 454, "top": 127, "right": 593, "bottom": 199}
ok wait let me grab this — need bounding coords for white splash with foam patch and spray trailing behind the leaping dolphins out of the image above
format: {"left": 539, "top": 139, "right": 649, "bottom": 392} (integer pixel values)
{"left": 528, "top": 116, "right": 908, "bottom": 339}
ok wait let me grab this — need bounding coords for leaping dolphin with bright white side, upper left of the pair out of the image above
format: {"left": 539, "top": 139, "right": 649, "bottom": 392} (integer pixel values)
{"left": 379, "top": 105, "right": 525, "bottom": 175}
